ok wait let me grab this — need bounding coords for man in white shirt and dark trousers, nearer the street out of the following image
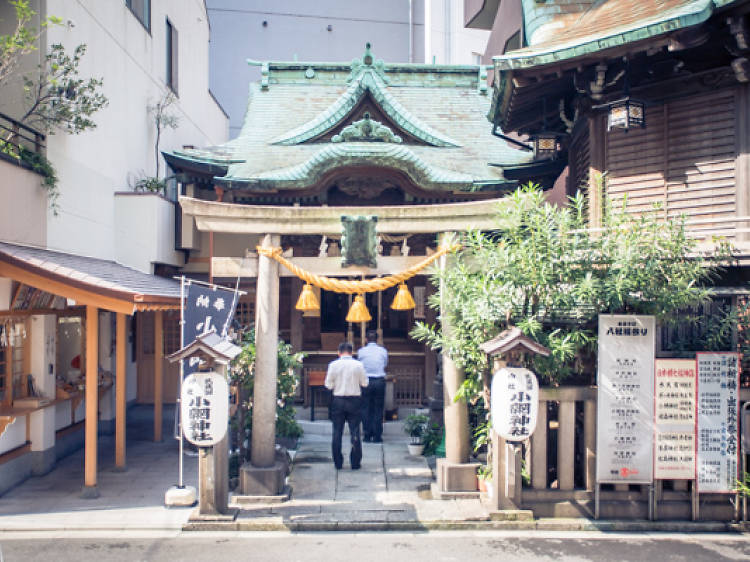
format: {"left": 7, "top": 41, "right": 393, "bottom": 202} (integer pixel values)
{"left": 325, "top": 342, "right": 368, "bottom": 470}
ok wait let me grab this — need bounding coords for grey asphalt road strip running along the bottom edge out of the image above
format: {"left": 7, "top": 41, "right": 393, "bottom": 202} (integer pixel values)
{"left": 0, "top": 531, "right": 750, "bottom": 562}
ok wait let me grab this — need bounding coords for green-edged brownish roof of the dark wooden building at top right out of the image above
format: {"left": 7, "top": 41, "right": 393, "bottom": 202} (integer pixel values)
{"left": 493, "top": 0, "right": 735, "bottom": 71}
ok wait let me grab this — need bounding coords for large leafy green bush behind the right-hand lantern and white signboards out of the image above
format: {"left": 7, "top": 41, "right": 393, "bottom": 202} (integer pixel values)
{"left": 412, "top": 185, "right": 731, "bottom": 403}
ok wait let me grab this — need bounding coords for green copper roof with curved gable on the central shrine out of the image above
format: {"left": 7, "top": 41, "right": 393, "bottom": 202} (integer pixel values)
{"left": 169, "top": 46, "right": 530, "bottom": 189}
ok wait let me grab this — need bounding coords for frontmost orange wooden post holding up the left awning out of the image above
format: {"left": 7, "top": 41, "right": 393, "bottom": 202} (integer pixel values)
{"left": 81, "top": 305, "right": 99, "bottom": 498}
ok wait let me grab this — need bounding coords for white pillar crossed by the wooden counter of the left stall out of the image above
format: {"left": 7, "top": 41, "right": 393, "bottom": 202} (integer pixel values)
{"left": 29, "top": 315, "right": 57, "bottom": 476}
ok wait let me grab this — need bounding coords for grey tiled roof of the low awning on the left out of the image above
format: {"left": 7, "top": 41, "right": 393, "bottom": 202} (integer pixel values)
{"left": 0, "top": 242, "right": 180, "bottom": 304}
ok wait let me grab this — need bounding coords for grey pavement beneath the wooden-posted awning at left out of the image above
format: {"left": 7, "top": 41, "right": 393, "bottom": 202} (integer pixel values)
{"left": 0, "top": 406, "right": 198, "bottom": 531}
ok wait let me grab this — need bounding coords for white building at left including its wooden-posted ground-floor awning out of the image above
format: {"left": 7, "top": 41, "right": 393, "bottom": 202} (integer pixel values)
{"left": 0, "top": 0, "right": 228, "bottom": 493}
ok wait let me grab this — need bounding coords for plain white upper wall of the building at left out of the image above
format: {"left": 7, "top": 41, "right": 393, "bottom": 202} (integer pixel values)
{"left": 41, "top": 0, "right": 227, "bottom": 271}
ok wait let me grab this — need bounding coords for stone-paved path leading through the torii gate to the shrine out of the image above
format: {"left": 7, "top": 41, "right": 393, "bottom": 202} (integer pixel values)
{"left": 212, "top": 421, "right": 489, "bottom": 530}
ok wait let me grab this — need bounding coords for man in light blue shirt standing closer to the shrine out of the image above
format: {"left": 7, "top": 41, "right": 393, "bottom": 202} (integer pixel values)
{"left": 357, "top": 330, "right": 388, "bottom": 443}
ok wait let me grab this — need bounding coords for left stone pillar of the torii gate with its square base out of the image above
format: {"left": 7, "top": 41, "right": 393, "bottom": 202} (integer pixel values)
{"left": 240, "top": 234, "right": 287, "bottom": 496}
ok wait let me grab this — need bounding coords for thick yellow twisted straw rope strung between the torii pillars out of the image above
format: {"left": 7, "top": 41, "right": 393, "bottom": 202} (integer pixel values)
{"left": 256, "top": 244, "right": 461, "bottom": 294}
